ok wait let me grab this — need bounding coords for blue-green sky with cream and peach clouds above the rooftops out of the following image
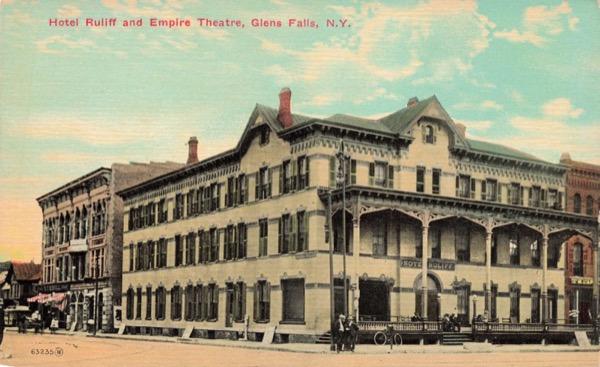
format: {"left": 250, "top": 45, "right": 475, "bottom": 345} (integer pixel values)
{"left": 0, "top": 0, "right": 600, "bottom": 262}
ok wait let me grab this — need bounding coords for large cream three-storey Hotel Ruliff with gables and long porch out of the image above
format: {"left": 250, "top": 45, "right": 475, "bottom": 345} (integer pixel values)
{"left": 118, "top": 89, "right": 597, "bottom": 341}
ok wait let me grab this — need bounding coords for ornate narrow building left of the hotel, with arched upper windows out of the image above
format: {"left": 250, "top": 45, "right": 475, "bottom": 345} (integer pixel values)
{"left": 37, "top": 163, "right": 181, "bottom": 331}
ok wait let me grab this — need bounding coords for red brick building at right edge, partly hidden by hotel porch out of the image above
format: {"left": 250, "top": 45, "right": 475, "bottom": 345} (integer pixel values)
{"left": 560, "top": 153, "right": 600, "bottom": 324}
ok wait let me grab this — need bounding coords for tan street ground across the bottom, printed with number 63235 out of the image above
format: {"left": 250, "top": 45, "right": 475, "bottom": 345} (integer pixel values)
{"left": 0, "top": 331, "right": 600, "bottom": 367}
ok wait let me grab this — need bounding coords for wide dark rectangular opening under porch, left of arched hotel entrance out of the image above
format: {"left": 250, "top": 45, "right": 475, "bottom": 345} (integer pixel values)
{"left": 358, "top": 279, "right": 390, "bottom": 321}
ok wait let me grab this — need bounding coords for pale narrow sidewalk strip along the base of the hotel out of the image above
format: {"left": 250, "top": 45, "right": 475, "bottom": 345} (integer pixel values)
{"left": 5, "top": 328, "right": 600, "bottom": 354}
